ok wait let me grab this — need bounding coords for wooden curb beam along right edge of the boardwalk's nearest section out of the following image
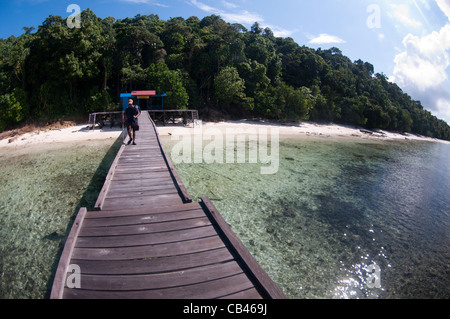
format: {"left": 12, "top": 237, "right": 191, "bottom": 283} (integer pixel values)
{"left": 201, "top": 197, "right": 286, "bottom": 299}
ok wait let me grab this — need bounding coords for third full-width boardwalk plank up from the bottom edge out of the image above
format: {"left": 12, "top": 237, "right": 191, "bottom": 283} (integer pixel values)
{"left": 72, "top": 247, "right": 234, "bottom": 275}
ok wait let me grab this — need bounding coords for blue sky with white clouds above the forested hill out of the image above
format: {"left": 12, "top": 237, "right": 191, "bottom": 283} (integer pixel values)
{"left": 0, "top": 0, "right": 450, "bottom": 123}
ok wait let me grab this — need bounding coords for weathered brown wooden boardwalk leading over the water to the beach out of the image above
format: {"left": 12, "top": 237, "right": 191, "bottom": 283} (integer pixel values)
{"left": 50, "top": 112, "right": 286, "bottom": 299}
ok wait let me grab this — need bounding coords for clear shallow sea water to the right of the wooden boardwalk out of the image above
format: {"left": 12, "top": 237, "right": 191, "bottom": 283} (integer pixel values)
{"left": 162, "top": 136, "right": 450, "bottom": 298}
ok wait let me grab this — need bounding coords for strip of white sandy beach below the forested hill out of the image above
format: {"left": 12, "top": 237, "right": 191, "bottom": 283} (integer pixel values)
{"left": 0, "top": 120, "right": 450, "bottom": 151}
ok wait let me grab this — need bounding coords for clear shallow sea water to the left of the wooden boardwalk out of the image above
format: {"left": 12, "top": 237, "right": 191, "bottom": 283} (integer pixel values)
{"left": 0, "top": 139, "right": 122, "bottom": 299}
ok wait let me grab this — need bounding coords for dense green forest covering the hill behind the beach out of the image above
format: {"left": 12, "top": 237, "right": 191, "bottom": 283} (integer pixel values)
{"left": 0, "top": 9, "right": 450, "bottom": 140}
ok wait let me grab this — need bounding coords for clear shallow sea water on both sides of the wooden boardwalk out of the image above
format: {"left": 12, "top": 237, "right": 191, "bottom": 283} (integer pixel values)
{"left": 0, "top": 129, "right": 450, "bottom": 298}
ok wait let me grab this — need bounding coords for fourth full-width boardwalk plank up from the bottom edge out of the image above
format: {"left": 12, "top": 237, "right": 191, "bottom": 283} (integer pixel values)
{"left": 72, "top": 236, "right": 225, "bottom": 260}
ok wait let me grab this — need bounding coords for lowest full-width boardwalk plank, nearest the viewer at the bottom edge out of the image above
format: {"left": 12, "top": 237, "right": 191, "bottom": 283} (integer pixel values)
{"left": 64, "top": 274, "right": 253, "bottom": 299}
